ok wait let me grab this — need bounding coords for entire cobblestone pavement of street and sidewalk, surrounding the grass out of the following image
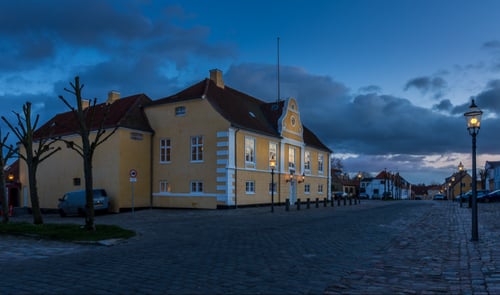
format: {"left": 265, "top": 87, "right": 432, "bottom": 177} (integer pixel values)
{"left": 0, "top": 201, "right": 500, "bottom": 295}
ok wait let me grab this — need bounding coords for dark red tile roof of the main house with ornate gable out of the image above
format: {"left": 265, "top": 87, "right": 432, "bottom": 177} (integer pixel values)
{"left": 146, "top": 78, "right": 331, "bottom": 152}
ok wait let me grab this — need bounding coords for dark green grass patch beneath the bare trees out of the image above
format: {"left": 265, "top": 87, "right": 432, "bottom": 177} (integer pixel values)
{"left": 0, "top": 222, "right": 135, "bottom": 242}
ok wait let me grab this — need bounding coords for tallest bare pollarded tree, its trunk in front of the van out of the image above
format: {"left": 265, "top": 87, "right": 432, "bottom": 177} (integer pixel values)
{"left": 59, "top": 77, "right": 117, "bottom": 231}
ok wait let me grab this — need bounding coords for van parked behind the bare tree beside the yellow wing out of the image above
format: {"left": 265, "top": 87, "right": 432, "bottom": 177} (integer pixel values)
{"left": 57, "top": 189, "right": 109, "bottom": 217}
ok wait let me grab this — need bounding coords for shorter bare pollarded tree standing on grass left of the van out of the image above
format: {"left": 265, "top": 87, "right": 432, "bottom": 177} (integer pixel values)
{"left": 2, "top": 102, "right": 60, "bottom": 224}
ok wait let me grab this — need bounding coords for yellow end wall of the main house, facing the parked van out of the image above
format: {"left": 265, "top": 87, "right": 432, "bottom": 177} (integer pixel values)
{"left": 145, "top": 99, "right": 230, "bottom": 208}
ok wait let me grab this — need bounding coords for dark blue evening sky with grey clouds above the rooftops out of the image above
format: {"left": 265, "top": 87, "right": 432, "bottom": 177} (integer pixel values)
{"left": 0, "top": 0, "right": 500, "bottom": 183}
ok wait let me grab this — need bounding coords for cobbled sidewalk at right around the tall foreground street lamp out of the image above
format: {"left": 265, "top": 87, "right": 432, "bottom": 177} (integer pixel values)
{"left": 325, "top": 202, "right": 500, "bottom": 295}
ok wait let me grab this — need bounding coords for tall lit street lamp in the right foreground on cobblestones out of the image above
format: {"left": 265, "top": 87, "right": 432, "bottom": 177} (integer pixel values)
{"left": 464, "top": 99, "right": 483, "bottom": 241}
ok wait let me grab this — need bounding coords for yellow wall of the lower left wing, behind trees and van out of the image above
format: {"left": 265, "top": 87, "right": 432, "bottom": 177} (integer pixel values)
{"left": 20, "top": 128, "right": 151, "bottom": 212}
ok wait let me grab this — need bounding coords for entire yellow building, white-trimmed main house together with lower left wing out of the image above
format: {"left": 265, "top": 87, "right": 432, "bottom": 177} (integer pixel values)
{"left": 20, "top": 70, "right": 331, "bottom": 212}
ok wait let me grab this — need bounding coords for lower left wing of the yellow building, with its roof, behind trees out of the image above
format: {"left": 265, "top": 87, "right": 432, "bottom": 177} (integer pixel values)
{"left": 23, "top": 92, "right": 153, "bottom": 212}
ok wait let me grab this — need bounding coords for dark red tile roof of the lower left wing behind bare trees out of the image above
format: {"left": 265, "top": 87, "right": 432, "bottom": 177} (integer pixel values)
{"left": 34, "top": 94, "right": 153, "bottom": 139}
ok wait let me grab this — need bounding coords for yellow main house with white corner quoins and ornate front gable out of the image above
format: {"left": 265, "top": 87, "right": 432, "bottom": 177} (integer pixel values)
{"left": 145, "top": 70, "right": 331, "bottom": 208}
